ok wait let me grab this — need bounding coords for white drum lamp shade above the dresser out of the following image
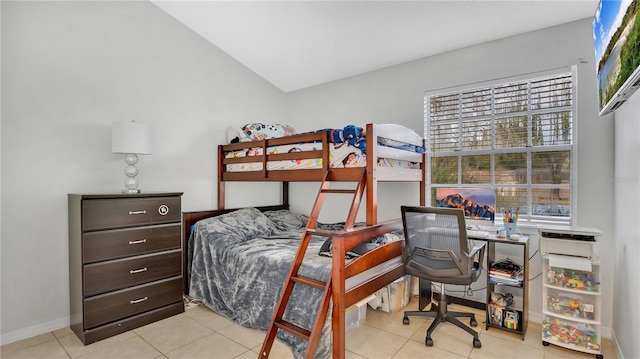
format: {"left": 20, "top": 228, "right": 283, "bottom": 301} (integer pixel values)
{"left": 111, "top": 121, "right": 151, "bottom": 155}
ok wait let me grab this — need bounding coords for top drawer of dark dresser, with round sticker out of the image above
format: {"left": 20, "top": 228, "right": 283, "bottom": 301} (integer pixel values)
{"left": 82, "top": 196, "right": 181, "bottom": 231}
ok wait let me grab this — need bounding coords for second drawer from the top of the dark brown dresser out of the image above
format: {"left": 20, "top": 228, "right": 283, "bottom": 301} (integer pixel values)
{"left": 82, "top": 223, "right": 181, "bottom": 263}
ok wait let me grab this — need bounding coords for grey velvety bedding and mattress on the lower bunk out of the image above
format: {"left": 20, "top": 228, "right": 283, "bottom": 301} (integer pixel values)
{"left": 188, "top": 208, "right": 402, "bottom": 358}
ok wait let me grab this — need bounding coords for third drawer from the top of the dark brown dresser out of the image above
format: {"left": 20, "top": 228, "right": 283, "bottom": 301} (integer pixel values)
{"left": 83, "top": 249, "right": 182, "bottom": 296}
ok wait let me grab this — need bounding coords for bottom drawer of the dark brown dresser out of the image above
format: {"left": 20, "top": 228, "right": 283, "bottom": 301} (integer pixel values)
{"left": 84, "top": 277, "right": 182, "bottom": 329}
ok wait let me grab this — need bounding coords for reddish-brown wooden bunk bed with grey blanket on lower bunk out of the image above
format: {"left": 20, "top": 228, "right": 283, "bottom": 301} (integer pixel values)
{"left": 183, "top": 124, "right": 425, "bottom": 358}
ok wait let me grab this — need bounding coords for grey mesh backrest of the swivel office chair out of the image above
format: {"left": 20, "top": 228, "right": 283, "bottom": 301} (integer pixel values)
{"left": 401, "top": 206, "right": 473, "bottom": 282}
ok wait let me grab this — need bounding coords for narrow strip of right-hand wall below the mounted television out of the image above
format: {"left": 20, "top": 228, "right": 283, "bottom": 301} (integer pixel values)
{"left": 611, "top": 92, "right": 640, "bottom": 359}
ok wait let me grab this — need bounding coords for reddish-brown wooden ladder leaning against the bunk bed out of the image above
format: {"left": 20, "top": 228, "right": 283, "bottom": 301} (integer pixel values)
{"left": 258, "top": 169, "right": 367, "bottom": 359}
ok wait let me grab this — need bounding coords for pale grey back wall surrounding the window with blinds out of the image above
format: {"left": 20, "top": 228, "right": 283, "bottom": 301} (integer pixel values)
{"left": 287, "top": 19, "right": 630, "bottom": 336}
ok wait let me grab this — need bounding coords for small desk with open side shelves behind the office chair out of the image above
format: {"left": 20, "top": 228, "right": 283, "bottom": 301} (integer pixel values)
{"left": 418, "top": 232, "right": 529, "bottom": 340}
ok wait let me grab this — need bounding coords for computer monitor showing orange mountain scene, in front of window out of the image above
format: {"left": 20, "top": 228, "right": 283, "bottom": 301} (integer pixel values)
{"left": 435, "top": 187, "right": 496, "bottom": 226}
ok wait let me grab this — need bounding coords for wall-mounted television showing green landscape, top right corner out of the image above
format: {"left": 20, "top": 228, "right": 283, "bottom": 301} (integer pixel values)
{"left": 593, "top": 0, "right": 640, "bottom": 116}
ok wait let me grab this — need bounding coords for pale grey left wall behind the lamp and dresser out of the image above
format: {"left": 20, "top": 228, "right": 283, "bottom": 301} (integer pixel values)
{"left": 0, "top": 1, "right": 285, "bottom": 344}
